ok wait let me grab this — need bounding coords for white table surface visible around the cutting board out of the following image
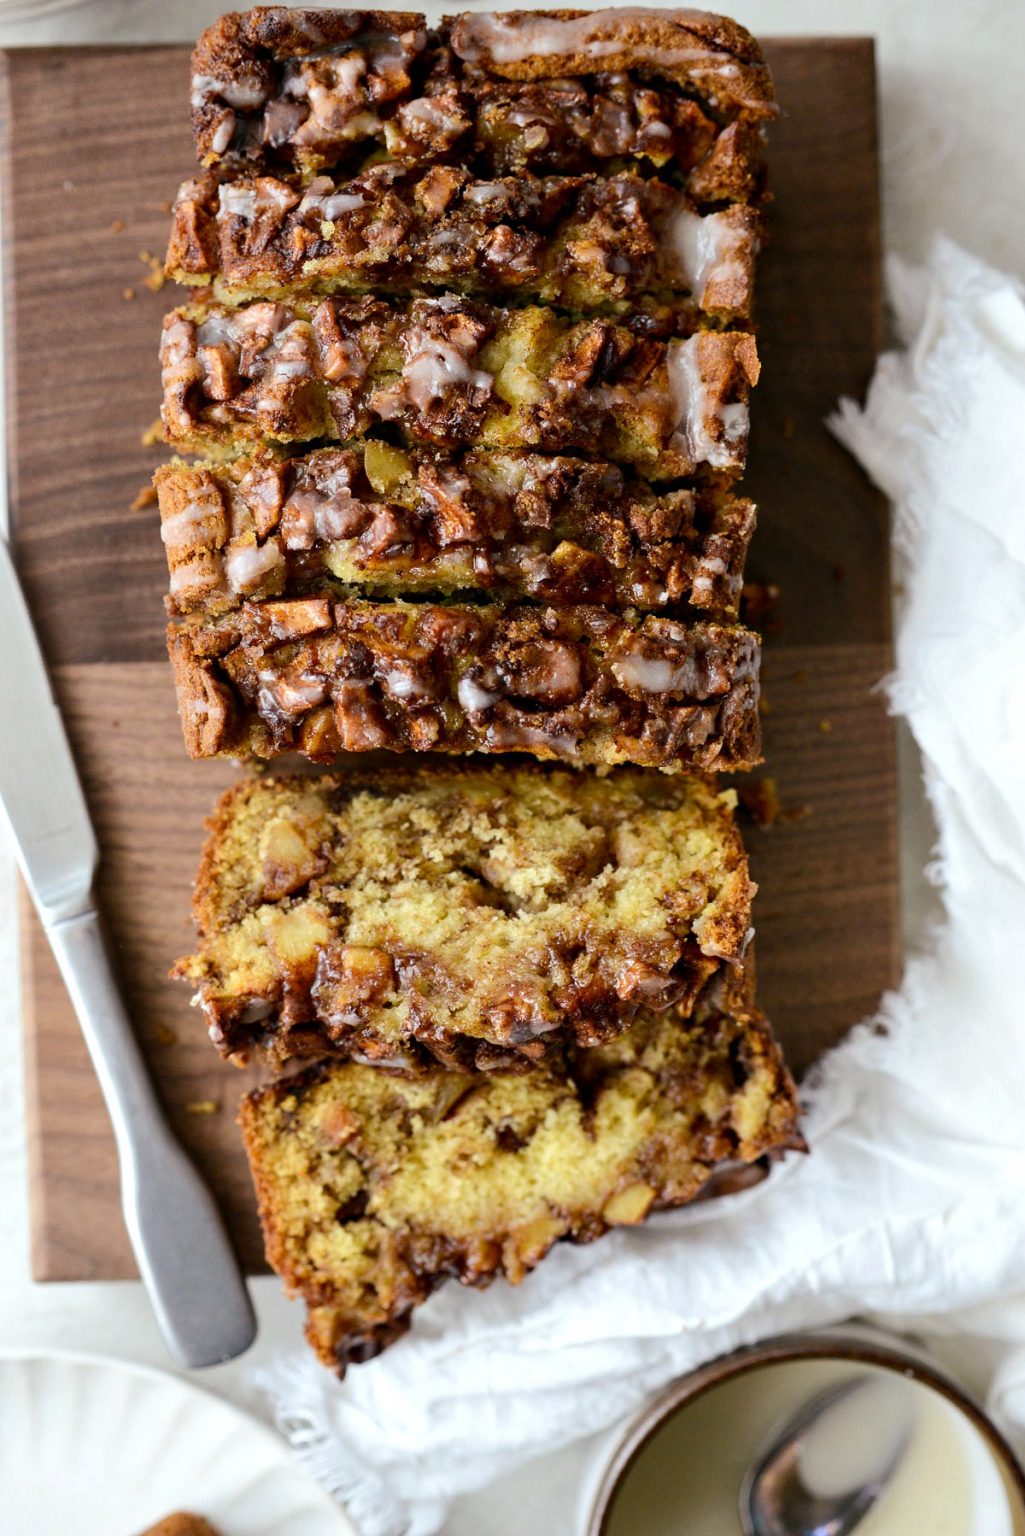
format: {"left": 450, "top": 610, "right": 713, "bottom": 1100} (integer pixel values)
{"left": 0, "top": 0, "right": 1025, "bottom": 1536}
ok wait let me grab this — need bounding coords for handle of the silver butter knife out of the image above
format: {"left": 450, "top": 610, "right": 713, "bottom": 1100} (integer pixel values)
{"left": 48, "top": 911, "right": 257, "bottom": 1367}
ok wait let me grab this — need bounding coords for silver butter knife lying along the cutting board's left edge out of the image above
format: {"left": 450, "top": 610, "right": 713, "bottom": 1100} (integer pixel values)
{"left": 0, "top": 539, "right": 257, "bottom": 1366}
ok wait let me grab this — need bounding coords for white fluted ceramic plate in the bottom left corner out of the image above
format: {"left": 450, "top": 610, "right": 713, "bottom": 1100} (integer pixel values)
{"left": 0, "top": 1352, "right": 355, "bottom": 1536}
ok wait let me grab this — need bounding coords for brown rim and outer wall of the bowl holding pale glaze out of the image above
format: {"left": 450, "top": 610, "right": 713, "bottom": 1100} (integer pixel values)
{"left": 579, "top": 1327, "right": 1025, "bottom": 1536}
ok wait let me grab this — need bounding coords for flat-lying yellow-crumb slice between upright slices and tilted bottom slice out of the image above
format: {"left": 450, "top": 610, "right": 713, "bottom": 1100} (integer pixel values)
{"left": 178, "top": 763, "right": 753, "bottom": 1069}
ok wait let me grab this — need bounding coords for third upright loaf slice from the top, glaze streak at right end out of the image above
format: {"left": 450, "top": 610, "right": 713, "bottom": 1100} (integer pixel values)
{"left": 160, "top": 295, "right": 759, "bottom": 481}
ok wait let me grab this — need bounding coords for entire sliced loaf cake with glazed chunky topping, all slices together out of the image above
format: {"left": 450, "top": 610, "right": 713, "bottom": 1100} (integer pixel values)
{"left": 155, "top": 8, "right": 794, "bottom": 1366}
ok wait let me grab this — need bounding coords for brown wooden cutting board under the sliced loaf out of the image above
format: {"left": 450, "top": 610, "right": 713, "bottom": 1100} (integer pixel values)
{"left": 0, "top": 38, "right": 897, "bottom": 1279}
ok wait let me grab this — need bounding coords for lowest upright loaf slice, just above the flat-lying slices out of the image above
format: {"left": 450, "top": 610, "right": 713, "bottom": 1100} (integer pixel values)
{"left": 168, "top": 595, "right": 761, "bottom": 773}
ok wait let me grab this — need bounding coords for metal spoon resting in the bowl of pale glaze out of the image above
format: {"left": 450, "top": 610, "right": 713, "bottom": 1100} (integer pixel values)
{"left": 741, "top": 1375, "right": 914, "bottom": 1536}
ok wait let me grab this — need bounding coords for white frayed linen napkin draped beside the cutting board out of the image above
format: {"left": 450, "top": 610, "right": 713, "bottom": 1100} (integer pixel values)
{"left": 255, "top": 241, "right": 1025, "bottom": 1536}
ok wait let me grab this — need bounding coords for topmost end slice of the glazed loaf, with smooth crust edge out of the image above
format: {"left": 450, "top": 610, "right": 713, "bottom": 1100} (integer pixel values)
{"left": 191, "top": 6, "right": 776, "bottom": 187}
